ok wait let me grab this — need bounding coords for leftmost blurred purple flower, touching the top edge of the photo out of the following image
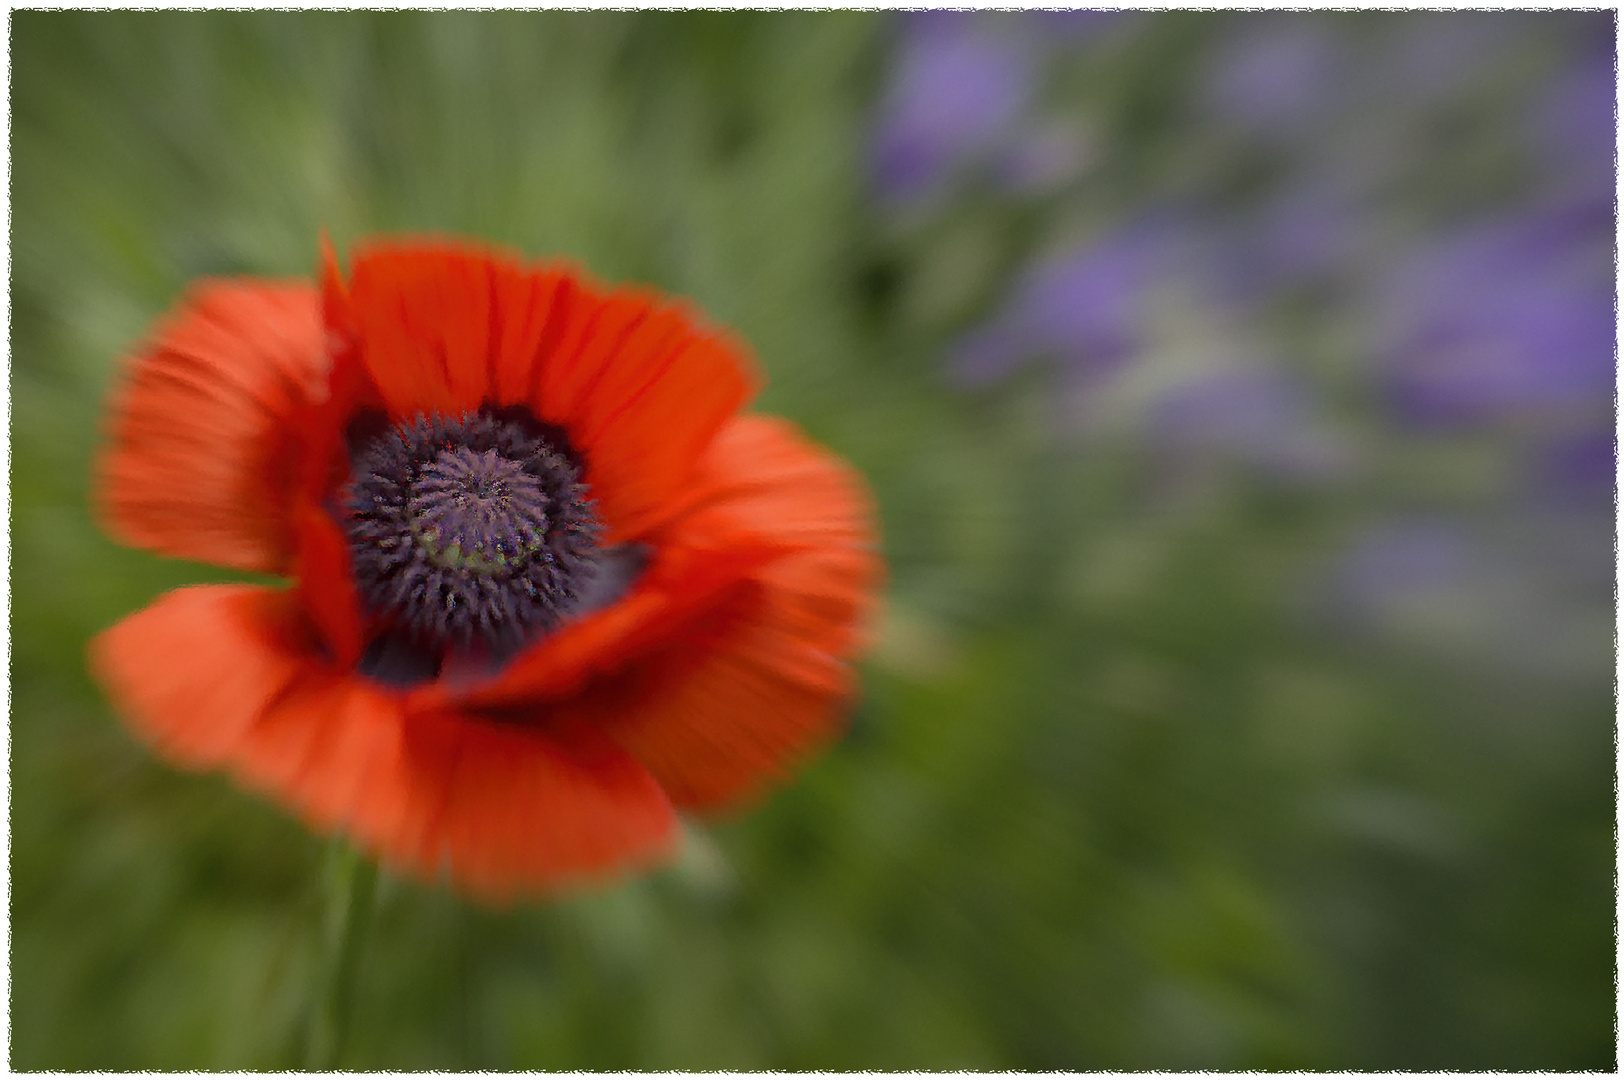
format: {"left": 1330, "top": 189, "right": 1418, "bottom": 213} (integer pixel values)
{"left": 874, "top": 11, "right": 1033, "bottom": 201}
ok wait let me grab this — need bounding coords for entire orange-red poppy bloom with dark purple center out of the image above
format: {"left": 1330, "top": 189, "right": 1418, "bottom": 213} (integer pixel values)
{"left": 91, "top": 244, "right": 879, "bottom": 900}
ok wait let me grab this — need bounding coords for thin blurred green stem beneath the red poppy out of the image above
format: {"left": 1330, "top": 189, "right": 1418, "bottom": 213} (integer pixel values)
{"left": 305, "top": 841, "right": 378, "bottom": 1072}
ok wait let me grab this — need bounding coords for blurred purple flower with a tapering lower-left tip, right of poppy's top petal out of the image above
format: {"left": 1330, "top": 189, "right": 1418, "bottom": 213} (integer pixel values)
{"left": 952, "top": 219, "right": 1179, "bottom": 385}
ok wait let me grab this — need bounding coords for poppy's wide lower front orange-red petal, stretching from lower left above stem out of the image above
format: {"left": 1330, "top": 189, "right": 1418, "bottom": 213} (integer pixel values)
{"left": 91, "top": 586, "right": 676, "bottom": 900}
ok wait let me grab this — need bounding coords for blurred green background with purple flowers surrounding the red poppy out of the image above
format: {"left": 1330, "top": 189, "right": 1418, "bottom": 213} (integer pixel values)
{"left": 10, "top": 11, "right": 1616, "bottom": 1069}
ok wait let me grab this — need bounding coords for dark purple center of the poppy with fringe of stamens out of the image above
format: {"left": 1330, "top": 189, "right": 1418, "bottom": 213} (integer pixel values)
{"left": 344, "top": 411, "right": 603, "bottom": 658}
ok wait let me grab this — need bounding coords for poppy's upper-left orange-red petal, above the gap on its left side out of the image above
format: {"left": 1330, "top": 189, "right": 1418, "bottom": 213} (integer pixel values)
{"left": 96, "top": 281, "right": 325, "bottom": 573}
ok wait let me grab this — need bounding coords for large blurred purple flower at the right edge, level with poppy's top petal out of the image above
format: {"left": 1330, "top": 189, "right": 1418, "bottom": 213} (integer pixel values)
{"left": 1376, "top": 207, "right": 1616, "bottom": 427}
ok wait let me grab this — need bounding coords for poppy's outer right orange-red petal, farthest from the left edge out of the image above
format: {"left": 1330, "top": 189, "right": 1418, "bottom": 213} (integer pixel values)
{"left": 607, "top": 417, "right": 880, "bottom": 809}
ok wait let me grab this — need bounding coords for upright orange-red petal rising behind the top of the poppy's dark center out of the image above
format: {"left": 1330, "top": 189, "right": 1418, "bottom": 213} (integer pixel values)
{"left": 348, "top": 244, "right": 754, "bottom": 544}
